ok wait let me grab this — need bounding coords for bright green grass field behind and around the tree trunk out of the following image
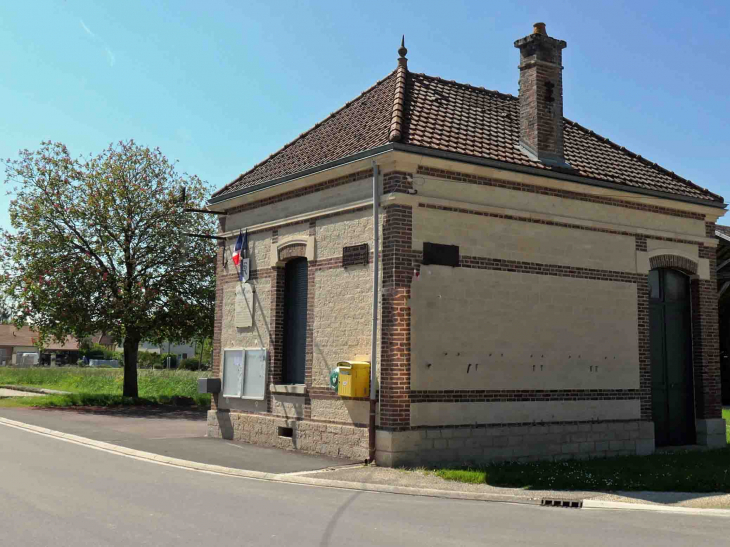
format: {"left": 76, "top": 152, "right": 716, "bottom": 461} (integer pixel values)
{"left": 0, "top": 367, "right": 210, "bottom": 407}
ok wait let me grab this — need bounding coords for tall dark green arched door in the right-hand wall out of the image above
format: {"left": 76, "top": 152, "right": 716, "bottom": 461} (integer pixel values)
{"left": 649, "top": 268, "right": 696, "bottom": 446}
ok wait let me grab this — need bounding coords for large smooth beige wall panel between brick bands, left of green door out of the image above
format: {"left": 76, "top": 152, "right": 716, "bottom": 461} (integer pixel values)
{"left": 411, "top": 266, "right": 639, "bottom": 396}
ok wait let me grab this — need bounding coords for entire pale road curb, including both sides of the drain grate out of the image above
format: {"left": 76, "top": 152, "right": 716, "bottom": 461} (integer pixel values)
{"left": 0, "top": 417, "right": 730, "bottom": 517}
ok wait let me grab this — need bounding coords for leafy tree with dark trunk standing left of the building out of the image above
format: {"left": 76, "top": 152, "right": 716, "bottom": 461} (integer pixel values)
{"left": 0, "top": 141, "right": 216, "bottom": 397}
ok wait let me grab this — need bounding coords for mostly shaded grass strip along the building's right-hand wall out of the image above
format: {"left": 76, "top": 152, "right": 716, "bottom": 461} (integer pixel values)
{"left": 430, "top": 414, "right": 730, "bottom": 492}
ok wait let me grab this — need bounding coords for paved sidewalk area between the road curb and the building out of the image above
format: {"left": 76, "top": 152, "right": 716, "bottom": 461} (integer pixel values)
{"left": 0, "top": 407, "right": 730, "bottom": 515}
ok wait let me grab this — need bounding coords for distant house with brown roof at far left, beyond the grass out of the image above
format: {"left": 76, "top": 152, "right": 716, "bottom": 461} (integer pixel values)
{"left": 0, "top": 325, "right": 79, "bottom": 366}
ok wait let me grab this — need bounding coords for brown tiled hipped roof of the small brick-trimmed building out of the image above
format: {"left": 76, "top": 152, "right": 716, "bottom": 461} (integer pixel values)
{"left": 213, "top": 67, "right": 722, "bottom": 202}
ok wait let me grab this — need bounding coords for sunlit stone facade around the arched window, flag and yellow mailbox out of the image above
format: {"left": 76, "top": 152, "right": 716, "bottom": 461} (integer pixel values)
{"left": 214, "top": 187, "right": 372, "bottom": 425}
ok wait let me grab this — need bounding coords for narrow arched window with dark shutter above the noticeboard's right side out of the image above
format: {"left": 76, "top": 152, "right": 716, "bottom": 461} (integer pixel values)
{"left": 283, "top": 258, "right": 308, "bottom": 384}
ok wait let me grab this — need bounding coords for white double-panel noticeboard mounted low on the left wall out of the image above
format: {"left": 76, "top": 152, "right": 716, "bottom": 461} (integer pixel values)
{"left": 223, "top": 348, "right": 266, "bottom": 401}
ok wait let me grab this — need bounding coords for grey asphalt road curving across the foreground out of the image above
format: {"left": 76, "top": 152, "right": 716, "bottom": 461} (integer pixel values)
{"left": 0, "top": 425, "right": 730, "bottom": 547}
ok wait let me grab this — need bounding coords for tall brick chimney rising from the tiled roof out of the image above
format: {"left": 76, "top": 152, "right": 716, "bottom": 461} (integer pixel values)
{"left": 515, "top": 23, "right": 570, "bottom": 168}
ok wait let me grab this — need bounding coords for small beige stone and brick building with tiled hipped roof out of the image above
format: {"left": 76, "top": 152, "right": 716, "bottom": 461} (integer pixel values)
{"left": 202, "top": 23, "right": 726, "bottom": 465}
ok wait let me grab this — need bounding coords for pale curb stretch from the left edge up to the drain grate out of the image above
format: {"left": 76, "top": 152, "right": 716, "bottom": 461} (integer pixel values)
{"left": 0, "top": 417, "right": 540, "bottom": 505}
